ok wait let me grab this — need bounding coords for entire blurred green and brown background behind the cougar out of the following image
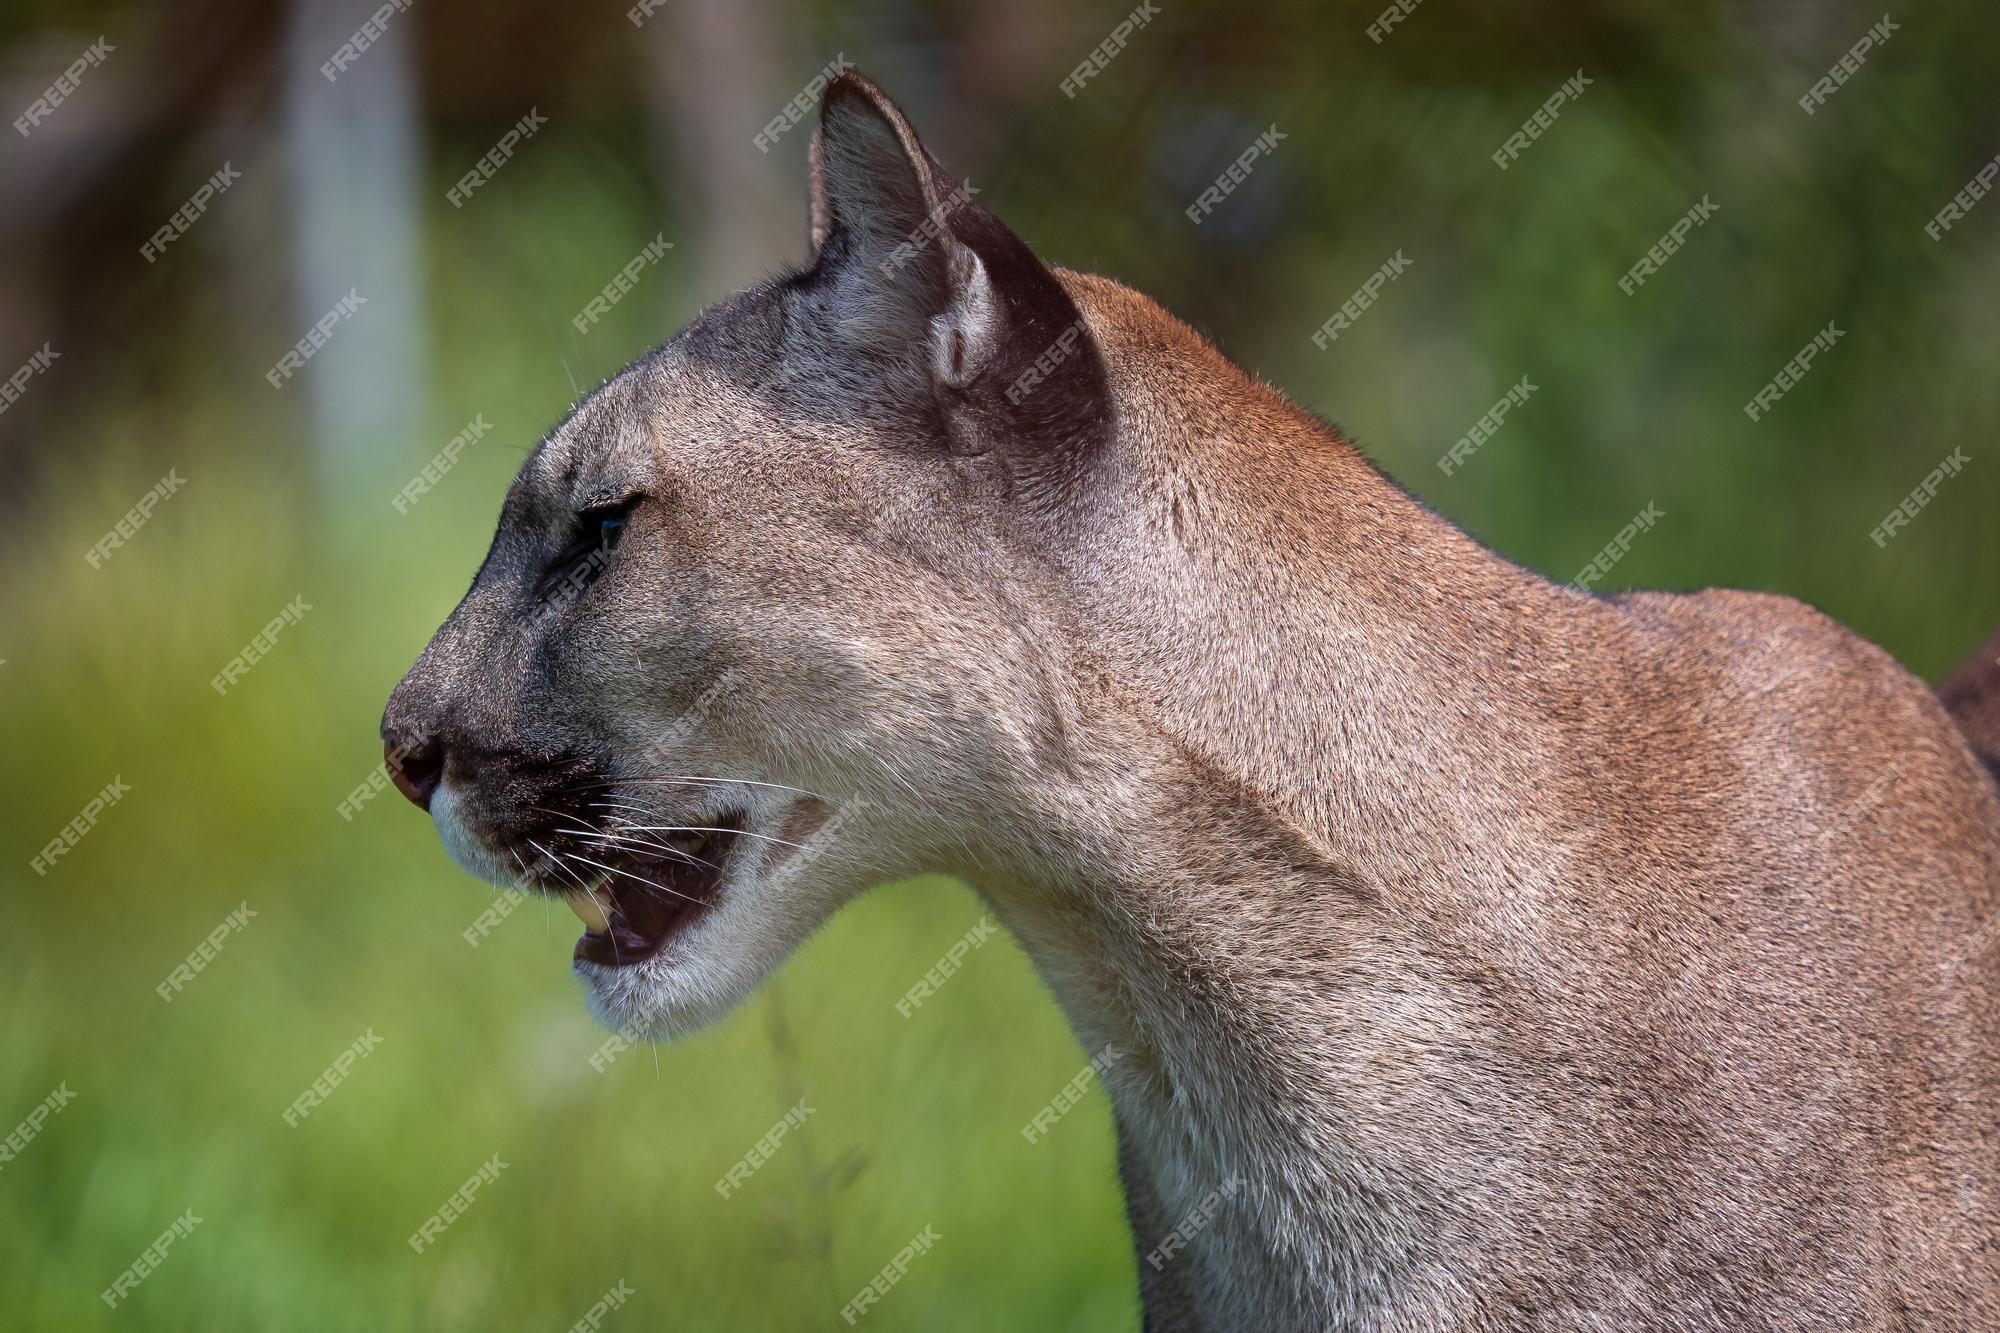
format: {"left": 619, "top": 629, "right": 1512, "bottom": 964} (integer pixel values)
{"left": 0, "top": 0, "right": 2000, "bottom": 1329}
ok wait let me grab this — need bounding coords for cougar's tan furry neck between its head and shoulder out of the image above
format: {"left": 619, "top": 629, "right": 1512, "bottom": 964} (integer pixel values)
{"left": 968, "top": 270, "right": 1640, "bottom": 1327}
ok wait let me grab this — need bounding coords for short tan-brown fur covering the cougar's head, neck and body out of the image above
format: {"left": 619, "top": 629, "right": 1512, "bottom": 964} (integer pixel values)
{"left": 384, "top": 76, "right": 2000, "bottom": 1333}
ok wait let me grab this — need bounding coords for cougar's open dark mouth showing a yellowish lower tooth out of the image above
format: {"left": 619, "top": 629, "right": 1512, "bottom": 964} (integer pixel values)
{"left": 562, "top": 813, "right": 744, "bottom": 967}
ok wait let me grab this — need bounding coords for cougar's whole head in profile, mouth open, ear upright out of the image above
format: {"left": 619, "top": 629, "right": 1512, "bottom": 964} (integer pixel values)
{"left": 382, "top": 78, "right": 1102, "bottom": 1033}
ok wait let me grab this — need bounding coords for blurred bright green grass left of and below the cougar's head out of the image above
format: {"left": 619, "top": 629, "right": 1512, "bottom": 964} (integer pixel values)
{"left": 0, "top": 190, "right": 1136, "bottom": 1329}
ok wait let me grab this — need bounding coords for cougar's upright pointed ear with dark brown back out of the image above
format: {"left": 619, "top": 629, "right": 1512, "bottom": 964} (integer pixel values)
{"left": 810, "top": 72, "right": 1110, "bottom": 466}
